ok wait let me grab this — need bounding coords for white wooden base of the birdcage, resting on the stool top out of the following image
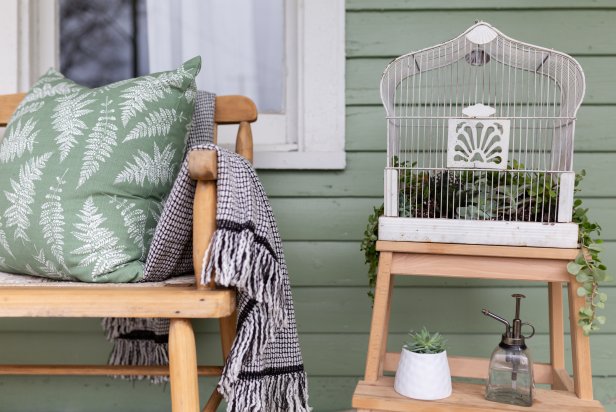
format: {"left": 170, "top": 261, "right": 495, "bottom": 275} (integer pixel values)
{"left": 379, "top": 217, "right": 578, "bottom": 248}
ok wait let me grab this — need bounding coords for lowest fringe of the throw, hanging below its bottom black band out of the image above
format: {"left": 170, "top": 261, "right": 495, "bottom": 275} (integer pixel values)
{"left": 219, "top": 371, "right": 312, "bottom": 412}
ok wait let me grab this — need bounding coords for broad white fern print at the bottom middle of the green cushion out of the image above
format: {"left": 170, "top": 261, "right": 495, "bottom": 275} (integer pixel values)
{"left": 71, "top": 197, "right": 130, "bottom": 279}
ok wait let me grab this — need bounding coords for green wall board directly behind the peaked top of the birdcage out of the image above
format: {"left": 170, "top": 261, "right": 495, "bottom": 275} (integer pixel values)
{"left": 346, "top": 9, "right": 616, "bottom": 57}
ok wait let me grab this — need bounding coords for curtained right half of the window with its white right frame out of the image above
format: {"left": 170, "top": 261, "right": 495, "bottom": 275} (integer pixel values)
{"left": 147, "top": 0, "right": 345, "bottom": 169}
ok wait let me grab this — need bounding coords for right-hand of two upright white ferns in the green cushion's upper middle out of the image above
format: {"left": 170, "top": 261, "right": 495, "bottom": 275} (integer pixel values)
{"left": 77, "top": 98, "right": 118, "bottom": 187}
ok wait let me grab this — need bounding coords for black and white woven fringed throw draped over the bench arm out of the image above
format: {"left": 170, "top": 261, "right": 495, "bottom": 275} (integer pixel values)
{"left": 103, "top": 91, "right": 310, "bottom": 412}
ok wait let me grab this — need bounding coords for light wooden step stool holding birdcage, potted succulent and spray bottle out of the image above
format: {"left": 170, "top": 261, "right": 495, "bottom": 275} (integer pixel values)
{"left": 353, "top": 241, "right": 604, "bottom": 412}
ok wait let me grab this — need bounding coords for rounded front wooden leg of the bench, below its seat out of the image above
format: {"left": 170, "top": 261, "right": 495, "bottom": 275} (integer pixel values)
{"left": 169, "top": 319, "right": 199, "bottom": 412}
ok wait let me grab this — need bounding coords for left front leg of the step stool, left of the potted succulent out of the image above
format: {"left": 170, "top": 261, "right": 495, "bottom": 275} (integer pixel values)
{"left": 365, "top": 252, "right": 393, "bottom": 382}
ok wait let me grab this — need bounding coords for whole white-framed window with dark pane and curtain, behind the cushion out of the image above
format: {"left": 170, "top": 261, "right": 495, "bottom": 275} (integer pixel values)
{"left": 0, "top": 0, "right": 345, "bottom": 169}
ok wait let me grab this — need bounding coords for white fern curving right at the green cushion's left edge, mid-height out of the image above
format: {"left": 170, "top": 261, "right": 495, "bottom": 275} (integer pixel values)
{"left": 4, "top": 152, "right": 51, "bottom": 242}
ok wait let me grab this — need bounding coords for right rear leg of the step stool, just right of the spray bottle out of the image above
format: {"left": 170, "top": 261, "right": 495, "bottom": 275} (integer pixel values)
{"left": 548, "top": 282, "right": 567, "bottom": 390}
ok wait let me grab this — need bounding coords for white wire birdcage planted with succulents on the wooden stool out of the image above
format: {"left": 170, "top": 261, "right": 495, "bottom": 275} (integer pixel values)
{"left": 379, "top": 22, "right": 585, "bottom": 247}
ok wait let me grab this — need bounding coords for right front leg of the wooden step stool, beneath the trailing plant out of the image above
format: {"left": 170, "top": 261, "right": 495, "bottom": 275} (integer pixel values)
{"left": 568, "top": 278, "right": 593, "bottom": 400}
